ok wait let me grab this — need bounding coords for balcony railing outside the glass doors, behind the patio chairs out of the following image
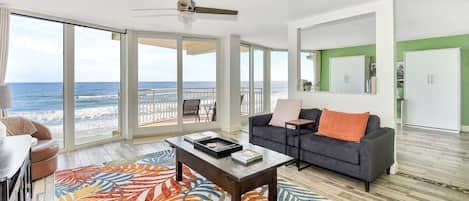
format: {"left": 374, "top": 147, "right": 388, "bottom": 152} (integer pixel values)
{"left": 138, "top": 88, "right": 264, "bottom": 126}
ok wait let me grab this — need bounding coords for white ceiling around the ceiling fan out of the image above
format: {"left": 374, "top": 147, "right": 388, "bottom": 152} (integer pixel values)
{"left": 0, "top": 0, "right": 469, "bottom": 48}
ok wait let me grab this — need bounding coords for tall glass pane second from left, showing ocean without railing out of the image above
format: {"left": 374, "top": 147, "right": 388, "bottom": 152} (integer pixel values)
{"left": 74, "top": 27, "right": 120, "bottom": 145}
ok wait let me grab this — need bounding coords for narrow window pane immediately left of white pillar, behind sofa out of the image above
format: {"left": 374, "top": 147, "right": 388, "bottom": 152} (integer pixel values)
{"left": 270, "top": 51, "right": 288, "bottom": 111}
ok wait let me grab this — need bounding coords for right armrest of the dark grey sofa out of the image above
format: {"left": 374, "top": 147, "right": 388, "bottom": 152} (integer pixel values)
{"left": 360, "top": 128, "right": 394, "bottom": 182}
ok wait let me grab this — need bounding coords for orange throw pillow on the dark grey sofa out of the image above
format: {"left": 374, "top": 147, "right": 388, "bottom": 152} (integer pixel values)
{"left": 318, "top": 109, "right": 370, "bottom": 143}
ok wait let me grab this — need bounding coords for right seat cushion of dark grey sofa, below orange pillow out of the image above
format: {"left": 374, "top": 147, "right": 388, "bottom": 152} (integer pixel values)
{"left": 301, "top": 134, "right": 360, "bottom": 164}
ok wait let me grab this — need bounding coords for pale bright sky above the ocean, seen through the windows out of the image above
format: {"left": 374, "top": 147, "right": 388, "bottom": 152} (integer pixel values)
{"left": 6, "top": 15, "right": 288, "bottom": 83}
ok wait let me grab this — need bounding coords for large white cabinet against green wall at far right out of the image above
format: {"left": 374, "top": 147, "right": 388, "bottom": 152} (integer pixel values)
{"left": 404, "top": 48, "right": 461, "bottom": 132}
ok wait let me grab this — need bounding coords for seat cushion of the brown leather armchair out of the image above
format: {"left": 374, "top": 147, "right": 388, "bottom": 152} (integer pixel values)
{"left": 31, "top": 140, "right": 59, "bottom": 163}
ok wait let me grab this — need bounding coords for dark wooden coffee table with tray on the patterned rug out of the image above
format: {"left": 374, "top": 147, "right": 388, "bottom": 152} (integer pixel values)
{"left": 166, "top": 133, "right": 294, "bottom": 201}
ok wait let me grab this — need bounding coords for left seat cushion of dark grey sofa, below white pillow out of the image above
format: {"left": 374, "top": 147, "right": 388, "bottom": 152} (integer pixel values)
{"left": 251, "top": 126, "right": 313, "bottom": 144}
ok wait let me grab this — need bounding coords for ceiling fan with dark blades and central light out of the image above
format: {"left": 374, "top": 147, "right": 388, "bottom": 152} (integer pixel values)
{"left": 132, "top": 0, "right": 238, "bottom": 23}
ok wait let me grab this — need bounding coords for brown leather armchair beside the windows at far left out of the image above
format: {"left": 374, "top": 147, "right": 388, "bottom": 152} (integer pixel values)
{"left": 31, "top": 122, "right": 59, "bottom": 180}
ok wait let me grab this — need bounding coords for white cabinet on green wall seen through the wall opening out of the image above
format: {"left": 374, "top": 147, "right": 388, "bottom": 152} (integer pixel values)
{"left": 329, "top": 56, "right": 369, "bottom": 93}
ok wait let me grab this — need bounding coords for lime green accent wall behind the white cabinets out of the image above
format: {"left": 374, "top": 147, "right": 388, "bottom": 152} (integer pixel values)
{"left": 321, "top": 34, "right": 469, "bottom": 125}
